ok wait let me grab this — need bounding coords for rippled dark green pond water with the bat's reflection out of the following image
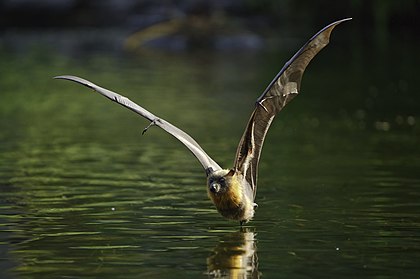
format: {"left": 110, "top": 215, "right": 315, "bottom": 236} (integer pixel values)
{"left": 0, "top": 28, "right": 420, "bottom": 278}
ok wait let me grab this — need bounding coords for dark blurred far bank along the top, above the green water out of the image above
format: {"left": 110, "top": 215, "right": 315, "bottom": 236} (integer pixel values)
{"left": 0, "top": 0, "right": 420, "bottom": 50}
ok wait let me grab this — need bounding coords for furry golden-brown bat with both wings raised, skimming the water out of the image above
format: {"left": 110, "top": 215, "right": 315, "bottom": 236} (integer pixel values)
{"left": 55, "top": 18, "right": 351, "bottom": 225}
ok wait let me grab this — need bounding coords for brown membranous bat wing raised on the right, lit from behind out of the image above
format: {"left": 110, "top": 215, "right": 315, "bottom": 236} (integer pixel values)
{"left": 234, "top": 18, "right": 351, "bottom": 197}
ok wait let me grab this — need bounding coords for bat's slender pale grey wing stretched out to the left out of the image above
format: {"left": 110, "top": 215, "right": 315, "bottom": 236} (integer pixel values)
{"left": 55, "top": 76, "right": 221, "bottom": 175}
